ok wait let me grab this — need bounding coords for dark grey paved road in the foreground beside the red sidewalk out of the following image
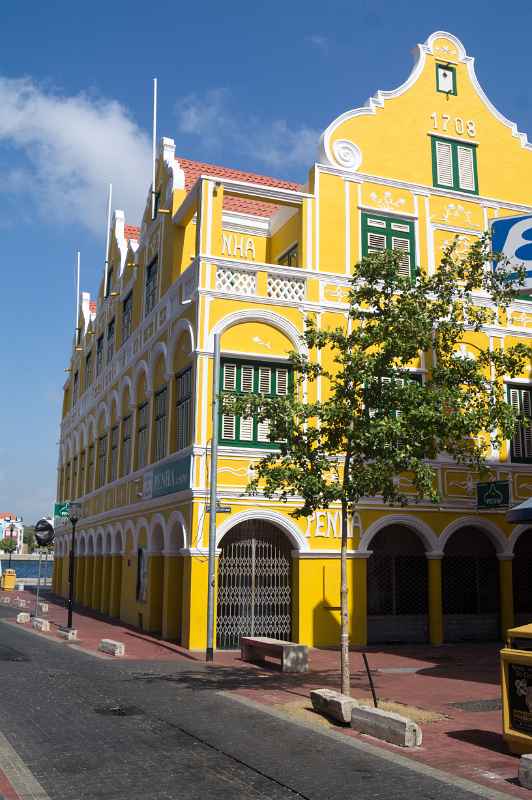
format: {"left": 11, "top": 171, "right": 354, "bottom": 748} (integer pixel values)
{"left": 0, "top": 608, "right": 512, "bottom": 800}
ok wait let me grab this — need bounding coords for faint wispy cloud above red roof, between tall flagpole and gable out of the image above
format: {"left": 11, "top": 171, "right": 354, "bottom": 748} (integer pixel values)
{"left": 176, "top": 88, "right": 320, "bottom": 170}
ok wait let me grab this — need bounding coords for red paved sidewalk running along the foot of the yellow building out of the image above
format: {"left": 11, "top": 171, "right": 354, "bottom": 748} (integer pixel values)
{"left": 0, "top": 592, "right": 530, "bottom": 797}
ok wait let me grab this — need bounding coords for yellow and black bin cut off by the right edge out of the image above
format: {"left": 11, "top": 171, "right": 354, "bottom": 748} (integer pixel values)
{"left": 501, "top": 625, "right": 532, "bottom": 755}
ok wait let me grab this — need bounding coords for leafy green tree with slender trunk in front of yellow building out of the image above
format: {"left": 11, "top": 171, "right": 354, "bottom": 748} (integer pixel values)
{"left": 222, "top": 237, "right": 532, "bottom": 694}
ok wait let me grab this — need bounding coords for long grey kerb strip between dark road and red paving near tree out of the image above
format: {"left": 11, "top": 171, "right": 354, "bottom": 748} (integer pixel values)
{"left": 225, "top": 691, "right": 515, "bottom": 800}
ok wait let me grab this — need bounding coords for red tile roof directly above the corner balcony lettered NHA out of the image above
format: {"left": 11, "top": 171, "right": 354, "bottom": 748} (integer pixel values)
{"left": 178, "top": 157, "right": 301, "bottom": 217}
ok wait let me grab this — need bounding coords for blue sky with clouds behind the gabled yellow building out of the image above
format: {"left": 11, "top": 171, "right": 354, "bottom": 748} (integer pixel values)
{"left": 0, "top": 0, "right": 532, "bottom": 523}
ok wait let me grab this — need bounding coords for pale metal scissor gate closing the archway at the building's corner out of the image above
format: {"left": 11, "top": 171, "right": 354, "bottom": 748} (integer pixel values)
{"left": 216, "top": 520, "right": 292, "bottom": 650}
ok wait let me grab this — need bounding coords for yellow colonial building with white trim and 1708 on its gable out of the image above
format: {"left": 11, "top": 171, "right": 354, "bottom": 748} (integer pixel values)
{"left": 54, "top": 32, "right": 532, "bottom": 649}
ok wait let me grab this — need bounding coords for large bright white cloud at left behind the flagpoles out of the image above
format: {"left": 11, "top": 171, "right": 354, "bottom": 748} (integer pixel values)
{"left": 0, "top": 78, "right": 151, "bottom": 237}
